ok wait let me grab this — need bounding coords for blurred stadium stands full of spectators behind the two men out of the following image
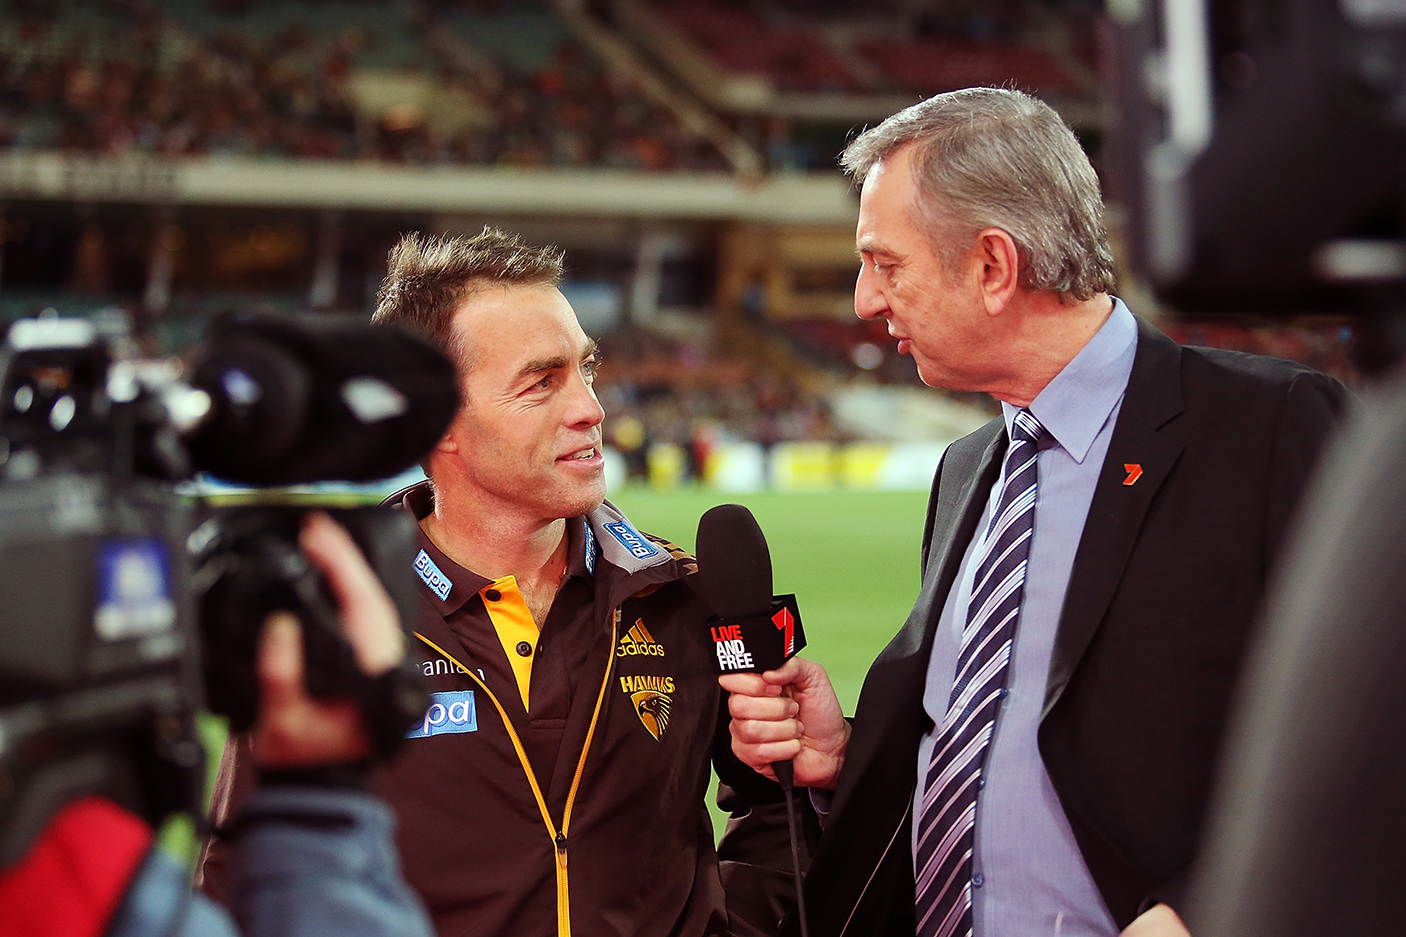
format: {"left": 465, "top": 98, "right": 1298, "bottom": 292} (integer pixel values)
{"left": 0, "top": 0, "right": 1355, "bottom": 464}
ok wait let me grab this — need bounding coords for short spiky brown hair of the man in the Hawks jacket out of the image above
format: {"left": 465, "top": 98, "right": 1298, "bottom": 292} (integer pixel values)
{"left": 371, "top": 227, "right": 564, "bottom": 369}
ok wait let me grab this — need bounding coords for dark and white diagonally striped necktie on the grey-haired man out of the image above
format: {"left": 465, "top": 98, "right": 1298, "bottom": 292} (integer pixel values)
{"left": 914, "top": 409, "right": 1047, "bottom": 937}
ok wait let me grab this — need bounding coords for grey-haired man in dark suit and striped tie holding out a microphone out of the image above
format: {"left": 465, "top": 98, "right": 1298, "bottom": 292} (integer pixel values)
{"left": 723, "top": 89, "right": 1346, "bottom": 937}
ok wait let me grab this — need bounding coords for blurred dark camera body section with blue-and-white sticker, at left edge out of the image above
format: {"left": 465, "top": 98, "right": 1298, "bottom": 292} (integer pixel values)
{"left": 0, "top": 474, "right": 204, "bottom": 867}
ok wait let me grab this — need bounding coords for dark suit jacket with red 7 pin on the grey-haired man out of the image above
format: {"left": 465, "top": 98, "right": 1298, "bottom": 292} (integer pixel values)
{"left": 792, "top": 322, "right": 1347, "bottom": 937}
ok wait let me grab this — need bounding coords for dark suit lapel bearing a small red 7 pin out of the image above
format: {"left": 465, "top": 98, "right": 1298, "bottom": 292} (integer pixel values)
{"left": 1040, "top": 319, "right": 1184, "bottom": 719}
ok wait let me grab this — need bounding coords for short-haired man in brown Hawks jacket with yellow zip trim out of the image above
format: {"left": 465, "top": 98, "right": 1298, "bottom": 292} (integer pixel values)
{"left": 201, "top": 229, "right": 783, "bottom": 937}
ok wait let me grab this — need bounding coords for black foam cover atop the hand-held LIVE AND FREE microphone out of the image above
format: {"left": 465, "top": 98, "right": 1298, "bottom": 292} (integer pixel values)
{"left": 697, "top": 504, "right": 772, "bottom": 619}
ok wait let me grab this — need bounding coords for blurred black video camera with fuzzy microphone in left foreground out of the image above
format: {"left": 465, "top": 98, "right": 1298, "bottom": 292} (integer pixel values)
{"left": 0, "top": 315, "right": 458, "bottom": 868}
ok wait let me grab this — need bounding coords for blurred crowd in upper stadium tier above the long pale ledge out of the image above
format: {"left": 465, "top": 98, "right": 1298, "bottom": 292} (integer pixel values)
{"left": 0, "top": 0, "right": 1097, "bottom": 172}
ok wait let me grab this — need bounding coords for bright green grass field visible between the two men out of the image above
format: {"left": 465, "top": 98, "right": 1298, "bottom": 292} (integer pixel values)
{"left": 181, "top": 487, "right": 927, "bottom": 858}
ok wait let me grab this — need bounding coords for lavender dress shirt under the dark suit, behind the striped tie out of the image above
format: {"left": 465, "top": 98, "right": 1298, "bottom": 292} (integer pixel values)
{"left": 912, "top": 300, "right": 1137, "bottom": 937}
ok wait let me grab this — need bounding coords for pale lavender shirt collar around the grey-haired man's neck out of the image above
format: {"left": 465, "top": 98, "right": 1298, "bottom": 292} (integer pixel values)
{"left": 1001, "top": 297, "right": 1137, "bottom": 464}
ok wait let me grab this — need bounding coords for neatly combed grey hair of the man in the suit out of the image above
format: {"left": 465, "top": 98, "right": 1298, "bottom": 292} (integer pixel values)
{"left": 839, "top": 87, "right": 1114, "bottom": 301}
